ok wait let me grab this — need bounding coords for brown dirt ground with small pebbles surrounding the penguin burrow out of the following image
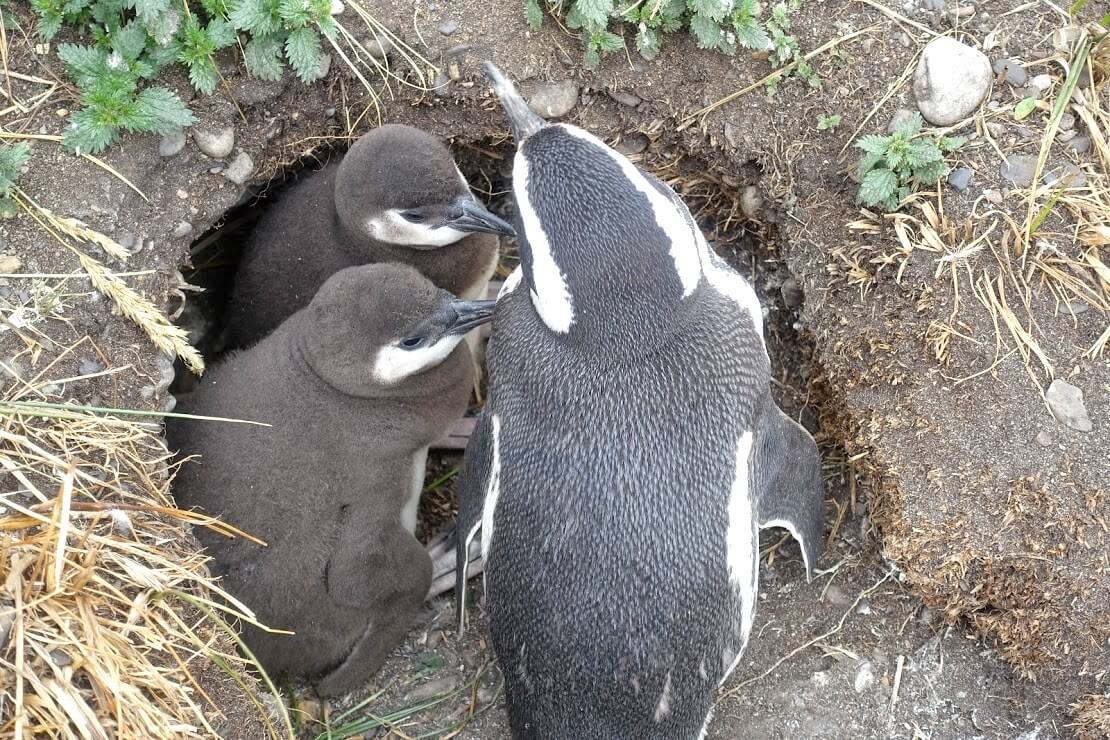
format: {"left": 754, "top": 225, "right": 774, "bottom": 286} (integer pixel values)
{"left": 0, "top": 0, "right": 1110, "bottom": 739}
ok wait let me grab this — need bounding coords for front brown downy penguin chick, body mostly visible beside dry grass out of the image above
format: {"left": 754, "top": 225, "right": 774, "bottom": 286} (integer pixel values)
{"left": 167, "top": 264, "right": 493, "bottom": 696}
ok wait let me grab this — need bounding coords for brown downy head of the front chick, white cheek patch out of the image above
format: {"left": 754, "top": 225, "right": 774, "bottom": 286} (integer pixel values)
{"left": 297, "top": 263, "right": 494, "bottom": 396}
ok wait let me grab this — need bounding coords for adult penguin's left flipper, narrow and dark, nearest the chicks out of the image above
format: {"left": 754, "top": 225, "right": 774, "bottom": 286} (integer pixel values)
{"left": 455, "top": 412, "right": 494, "bottom": 632}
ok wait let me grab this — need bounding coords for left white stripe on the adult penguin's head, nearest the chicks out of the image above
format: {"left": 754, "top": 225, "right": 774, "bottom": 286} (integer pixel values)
{"left": 513, "top": 149, "right": 574, "bottom": 334}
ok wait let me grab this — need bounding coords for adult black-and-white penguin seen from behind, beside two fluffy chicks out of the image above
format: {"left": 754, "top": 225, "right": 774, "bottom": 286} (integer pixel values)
{"left": 457, "top": 65, "right": 824, "bottom": 740}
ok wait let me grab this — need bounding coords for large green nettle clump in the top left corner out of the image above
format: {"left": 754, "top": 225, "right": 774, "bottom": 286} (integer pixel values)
{"left": 31, "top": 0, "right": 335, "bottom": 154}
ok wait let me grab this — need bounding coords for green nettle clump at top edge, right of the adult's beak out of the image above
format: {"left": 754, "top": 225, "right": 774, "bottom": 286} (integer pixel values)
{"left": 524, "top": 0, "right": 816, "bottom": 69}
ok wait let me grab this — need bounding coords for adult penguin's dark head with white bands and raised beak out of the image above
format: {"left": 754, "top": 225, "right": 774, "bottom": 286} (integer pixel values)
{"left": 487, "top": 65, "right": 708, "bottom": 352}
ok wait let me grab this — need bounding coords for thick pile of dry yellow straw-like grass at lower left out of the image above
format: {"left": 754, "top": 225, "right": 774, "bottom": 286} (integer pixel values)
{"left": 0, "top": 404, "right": 287, "bottom": 739}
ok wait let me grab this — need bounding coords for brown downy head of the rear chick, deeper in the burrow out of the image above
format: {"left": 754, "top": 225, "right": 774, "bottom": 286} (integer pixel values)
{"left": 335, "top": 124, "right": 513, "bottom": 250}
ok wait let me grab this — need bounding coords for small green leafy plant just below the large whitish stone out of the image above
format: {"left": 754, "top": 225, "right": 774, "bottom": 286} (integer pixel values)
{"left": 856, "top": 113, "right": 967, "bottom": 211}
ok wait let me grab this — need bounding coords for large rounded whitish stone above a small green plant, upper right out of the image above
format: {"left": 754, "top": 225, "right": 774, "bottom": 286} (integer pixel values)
{"left": 914, "top": 37, "right": 992, "bottom": 125}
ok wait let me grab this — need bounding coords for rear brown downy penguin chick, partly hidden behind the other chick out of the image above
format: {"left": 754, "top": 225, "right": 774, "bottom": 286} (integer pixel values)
{"left": 224, "top": 124, "right": 513, "bottom": 348}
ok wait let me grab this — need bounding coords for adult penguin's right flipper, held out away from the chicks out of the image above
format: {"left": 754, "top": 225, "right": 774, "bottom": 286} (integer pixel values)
{"left": 751, "top": 401, "right": 825, "bottom": 579}
